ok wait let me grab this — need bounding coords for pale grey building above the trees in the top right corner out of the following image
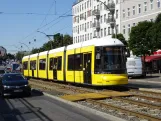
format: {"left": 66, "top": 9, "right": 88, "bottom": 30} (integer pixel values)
{"left": 120, "top": 0, "right": 161, "bottom": 40}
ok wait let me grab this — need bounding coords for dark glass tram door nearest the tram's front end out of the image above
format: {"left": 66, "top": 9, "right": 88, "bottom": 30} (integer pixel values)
{"left": 83, "top": 53, "right": 92, "bottom": 84}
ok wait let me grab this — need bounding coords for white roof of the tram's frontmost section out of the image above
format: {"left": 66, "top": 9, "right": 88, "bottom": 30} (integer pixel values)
{"left": 67, "top": 36, "right": 124, "bottom": 50}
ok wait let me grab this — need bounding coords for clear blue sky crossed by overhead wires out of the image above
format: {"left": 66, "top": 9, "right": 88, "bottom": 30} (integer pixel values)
{"left": 0, "top": 0, "right": 75, "bottom": 53}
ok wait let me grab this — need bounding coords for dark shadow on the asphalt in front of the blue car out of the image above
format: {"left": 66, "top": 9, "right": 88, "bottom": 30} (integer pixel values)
{"left": 0, "top": 90, "right": 52, "bottom": 121}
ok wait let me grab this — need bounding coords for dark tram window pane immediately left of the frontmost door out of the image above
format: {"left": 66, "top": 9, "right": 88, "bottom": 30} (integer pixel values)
{"left": 74, "top": 54, "right": 82, "bottom": 71}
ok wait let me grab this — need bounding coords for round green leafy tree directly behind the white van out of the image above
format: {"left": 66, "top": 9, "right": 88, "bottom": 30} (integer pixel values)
{"left": 129, "top": 21, "right": 153, "bottom": 61}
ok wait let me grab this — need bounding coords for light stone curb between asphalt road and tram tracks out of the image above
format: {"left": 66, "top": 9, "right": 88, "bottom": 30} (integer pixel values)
{"left": 34, "top": 89, "right": 126, "bottom": 121}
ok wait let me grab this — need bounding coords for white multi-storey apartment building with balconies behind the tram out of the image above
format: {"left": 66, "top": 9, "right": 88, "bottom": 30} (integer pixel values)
{"left": 72, "top": 0, "right": 120, "bottom": 43}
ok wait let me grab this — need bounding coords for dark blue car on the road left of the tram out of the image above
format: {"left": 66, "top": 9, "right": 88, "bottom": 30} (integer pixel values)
{"left": 0, "top": 73, "right": 31, "bottom": 97}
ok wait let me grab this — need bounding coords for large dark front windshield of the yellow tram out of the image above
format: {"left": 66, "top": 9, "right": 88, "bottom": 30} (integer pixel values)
{"left": 95, "top": 47, "right": 126, "bottom": 74}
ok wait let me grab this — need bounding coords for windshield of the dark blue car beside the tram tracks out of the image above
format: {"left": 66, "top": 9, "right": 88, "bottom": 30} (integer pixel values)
{"left": 3, "top": 74, "right": 24, "bottom": 81}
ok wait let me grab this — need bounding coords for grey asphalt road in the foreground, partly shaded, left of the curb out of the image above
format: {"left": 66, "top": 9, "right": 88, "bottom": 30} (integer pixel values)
{"left": 0, "top": 92, "right": 110, "bottom": 121}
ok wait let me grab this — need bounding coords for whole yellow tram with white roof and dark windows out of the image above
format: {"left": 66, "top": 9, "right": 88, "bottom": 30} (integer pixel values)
{"left": 22, "top": 37, "right": 128, "bottom": 86}
